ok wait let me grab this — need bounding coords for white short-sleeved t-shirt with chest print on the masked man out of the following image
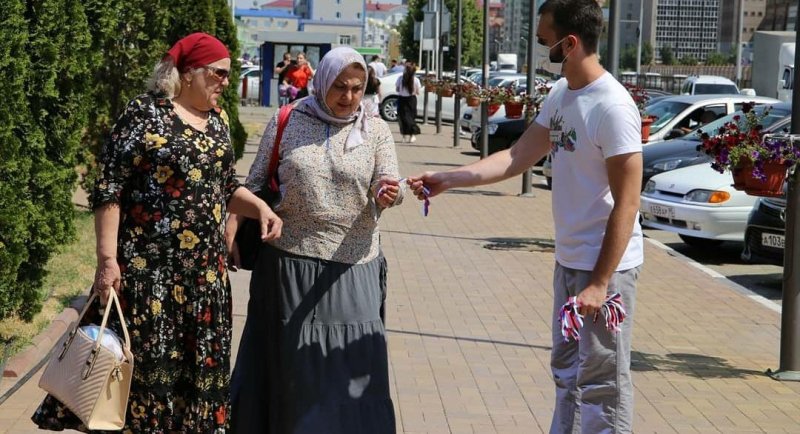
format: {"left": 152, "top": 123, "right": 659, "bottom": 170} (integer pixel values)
{"left": 536, "top": 72, "right": 644, "bottom": 271}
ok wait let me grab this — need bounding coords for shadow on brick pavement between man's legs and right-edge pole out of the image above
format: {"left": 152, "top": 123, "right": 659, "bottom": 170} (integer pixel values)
{"left": 631, "top": 351, "right": 764, "bottom": 378}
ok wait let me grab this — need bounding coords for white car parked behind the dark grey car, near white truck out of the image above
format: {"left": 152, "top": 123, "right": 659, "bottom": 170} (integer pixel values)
{"left": 646, "top": 95, "right": 780, "bottom": 144}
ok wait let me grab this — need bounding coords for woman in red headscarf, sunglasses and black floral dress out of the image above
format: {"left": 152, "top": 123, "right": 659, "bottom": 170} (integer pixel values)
{"left": 32, "top": 33, "right": 281, "bottom": 433}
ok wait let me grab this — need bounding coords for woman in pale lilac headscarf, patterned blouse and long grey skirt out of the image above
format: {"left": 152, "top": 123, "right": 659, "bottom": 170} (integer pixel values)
{"left": 227, "top": 47, "right": 402, "bottom": 434}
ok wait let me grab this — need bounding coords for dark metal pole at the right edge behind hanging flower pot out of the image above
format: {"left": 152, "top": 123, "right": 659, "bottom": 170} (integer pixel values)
{"left": 768, "top": 0, "right": 800, "bottom": 381}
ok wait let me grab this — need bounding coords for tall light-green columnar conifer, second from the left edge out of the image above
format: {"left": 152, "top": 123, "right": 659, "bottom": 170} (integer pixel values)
{"left": 17, "top": 0, "right": 91, "bottom": 319}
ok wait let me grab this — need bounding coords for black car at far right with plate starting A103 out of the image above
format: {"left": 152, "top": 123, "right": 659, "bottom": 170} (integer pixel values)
{"left": 742, "top": 197, "right": 786, "bottom": 265}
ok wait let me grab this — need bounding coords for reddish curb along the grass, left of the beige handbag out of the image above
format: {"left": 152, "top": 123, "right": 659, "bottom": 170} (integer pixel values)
{"left": 0, "top": 295, "right": 88, "bottom": 404}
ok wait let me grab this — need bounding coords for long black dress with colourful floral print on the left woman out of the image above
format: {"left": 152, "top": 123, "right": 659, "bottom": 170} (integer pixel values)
{"left": 33, "top": 94, "right": 239, "bottom": 433}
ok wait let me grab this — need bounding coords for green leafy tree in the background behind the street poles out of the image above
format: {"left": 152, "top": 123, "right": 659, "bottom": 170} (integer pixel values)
{"left": 398, "top": 0, "right": 483, "bottom": 70}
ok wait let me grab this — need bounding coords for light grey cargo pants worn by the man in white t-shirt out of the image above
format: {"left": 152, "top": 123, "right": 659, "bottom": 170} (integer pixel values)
{"left": 550, "top": 263, "right": 641, "bottom": 434}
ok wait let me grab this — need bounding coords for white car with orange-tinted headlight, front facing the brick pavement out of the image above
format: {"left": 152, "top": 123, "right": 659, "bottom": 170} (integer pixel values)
{"left": 639, "top": 164, "right": 757, "bottom": 247}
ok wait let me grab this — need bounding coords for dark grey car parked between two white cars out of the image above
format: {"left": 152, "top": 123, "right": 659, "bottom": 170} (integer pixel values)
{"left": 642, "top": 102, "right": 792, "bottom": 189}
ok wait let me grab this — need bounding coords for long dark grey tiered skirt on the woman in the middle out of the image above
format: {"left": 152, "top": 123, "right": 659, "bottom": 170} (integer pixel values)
{"left": 231, "top": 245, "right": 396, "bottom": 434}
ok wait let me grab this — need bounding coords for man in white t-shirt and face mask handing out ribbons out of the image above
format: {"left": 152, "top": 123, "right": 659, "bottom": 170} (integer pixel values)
{"left": 409, "top": 0, "right": 644, "bottom": 434}
